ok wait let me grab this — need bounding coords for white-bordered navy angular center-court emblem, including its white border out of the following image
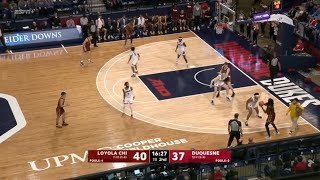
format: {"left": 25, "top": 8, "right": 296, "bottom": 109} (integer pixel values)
{"left": 0, "top": 93, "right": 27, "bottom": 143}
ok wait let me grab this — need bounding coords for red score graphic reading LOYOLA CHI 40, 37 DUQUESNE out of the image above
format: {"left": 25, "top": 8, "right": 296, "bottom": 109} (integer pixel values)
{"left": 88, "top": 150, "right": 231, "bottom": 163}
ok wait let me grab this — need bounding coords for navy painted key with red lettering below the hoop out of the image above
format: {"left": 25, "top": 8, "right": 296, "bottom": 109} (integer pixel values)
{"left": 139, "top": 64, "right": 256, "bottom": 100}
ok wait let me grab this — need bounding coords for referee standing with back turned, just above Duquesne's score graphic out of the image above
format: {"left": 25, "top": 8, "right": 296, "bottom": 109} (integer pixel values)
{"left": 228, "top": 113, "right": 243, "bottom": 148}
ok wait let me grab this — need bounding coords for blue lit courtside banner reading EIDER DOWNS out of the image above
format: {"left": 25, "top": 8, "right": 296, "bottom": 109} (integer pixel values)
{"left": 0, "top": 26, "right": 82, "bottom": 47}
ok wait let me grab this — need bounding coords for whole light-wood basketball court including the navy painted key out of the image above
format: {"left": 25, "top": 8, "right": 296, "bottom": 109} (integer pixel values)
{"left": 0, "top": 32, "right": 318, "bottom": 179}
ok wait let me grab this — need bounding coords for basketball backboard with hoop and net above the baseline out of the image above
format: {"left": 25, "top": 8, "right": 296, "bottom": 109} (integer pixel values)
{"left": 216, "top": 2, "right": 236, "bottom": 31}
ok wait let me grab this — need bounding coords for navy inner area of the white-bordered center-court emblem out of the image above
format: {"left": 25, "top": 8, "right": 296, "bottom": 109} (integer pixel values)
{"left": 0, "top": 97, "right": 17, "bottom": 136}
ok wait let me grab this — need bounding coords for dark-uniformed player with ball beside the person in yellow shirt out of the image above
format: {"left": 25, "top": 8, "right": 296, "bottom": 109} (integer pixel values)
{"left": 261, "top": 98, "right": 280, "bottom": 139}
